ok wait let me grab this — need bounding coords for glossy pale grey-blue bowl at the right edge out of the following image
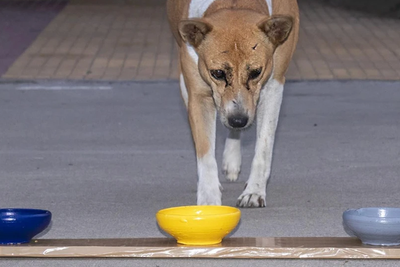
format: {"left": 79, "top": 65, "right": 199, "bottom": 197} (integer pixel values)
{"left": 343, "top": 207, "right": 400, "bottom": 246}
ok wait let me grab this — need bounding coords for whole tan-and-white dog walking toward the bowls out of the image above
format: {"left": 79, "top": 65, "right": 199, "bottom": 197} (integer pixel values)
{"left": 167, "top": 0, "right": 299, "bottom": 207}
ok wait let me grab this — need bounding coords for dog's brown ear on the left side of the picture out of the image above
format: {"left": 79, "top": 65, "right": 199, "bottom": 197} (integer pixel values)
{"left": 179, "top": 19, "right": 212, "bottom": 47}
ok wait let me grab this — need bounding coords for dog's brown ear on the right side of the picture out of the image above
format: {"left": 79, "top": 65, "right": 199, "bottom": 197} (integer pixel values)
{"left": 257, "top": 15, "right": 293, "bottom": 46}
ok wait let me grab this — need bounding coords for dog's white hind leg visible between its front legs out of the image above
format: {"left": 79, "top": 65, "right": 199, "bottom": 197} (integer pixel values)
{"left": 222, "top": 130, "right": 242, "bottom": 181}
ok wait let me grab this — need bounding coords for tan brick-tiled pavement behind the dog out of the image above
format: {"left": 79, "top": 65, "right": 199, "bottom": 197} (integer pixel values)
{"left": 2, "top": 0, "right": 400, "bottom": 80}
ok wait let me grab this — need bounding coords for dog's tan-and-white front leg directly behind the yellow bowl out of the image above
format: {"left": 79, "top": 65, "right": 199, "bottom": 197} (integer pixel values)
{"left": 188, "top": 93, "right": 221, "bottom": 205}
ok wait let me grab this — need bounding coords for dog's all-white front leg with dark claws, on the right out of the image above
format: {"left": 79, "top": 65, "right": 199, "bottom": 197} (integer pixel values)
{"left": 237, "top": 79, "right": 283, "bottom": 207}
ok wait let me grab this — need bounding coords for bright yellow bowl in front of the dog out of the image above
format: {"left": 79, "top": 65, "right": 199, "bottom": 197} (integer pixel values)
{"left": 156, "top": 206, "right": 240, "bottom": 245}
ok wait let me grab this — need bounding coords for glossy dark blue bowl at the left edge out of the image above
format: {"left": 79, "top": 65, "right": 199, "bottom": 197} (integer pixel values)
{"left": 0, "top": 209, "right": 51, "bottom": 245}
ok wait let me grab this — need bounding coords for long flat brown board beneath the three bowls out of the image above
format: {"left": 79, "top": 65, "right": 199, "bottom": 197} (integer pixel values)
{"left": 0, "top": 237, "right": 400, "bottom": 259}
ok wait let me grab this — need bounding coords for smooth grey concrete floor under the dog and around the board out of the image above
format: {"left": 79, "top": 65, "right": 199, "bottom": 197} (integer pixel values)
{"left": 0, "top": 81, "right": 400, "bottom": 267}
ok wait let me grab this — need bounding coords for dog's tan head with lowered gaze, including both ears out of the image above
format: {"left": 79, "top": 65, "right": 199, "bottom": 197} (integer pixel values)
{"left": 179, "top": 10, "right": 293, "bottom": 129}
